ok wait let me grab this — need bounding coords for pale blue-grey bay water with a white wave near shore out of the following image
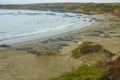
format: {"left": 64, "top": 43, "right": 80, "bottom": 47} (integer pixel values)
{"left": 0, "top": 9, "right": 94, "bottom": 44}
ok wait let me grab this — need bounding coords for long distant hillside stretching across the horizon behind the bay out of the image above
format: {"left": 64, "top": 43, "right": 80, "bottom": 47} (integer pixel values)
{"left": 0, "top": 3, "right": 120, "bottom": 16}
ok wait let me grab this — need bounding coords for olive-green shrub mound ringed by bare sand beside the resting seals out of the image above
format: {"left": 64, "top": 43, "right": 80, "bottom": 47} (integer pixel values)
{"left": 71, "top": 42, "right": 113, "bottom": 58}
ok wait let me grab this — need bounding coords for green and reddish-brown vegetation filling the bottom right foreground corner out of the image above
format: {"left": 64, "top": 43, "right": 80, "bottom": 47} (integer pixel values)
{"left": 51, "top": 57, "right": 120, "bottom": 80}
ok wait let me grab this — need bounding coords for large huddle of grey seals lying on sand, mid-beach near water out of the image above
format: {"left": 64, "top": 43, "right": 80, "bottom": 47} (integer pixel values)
{"left": 42, "top": 35, "right": 80, "bottom": 52}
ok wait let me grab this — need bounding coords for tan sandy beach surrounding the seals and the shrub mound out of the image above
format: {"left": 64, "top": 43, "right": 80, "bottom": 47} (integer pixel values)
{"left": 0, "top": 15, "right": 120, "bottom": 80}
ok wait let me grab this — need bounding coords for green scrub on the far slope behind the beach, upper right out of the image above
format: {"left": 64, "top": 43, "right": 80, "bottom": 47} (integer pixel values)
{"left": 75, "top": 4, "right": 120, "bottom": 14}
